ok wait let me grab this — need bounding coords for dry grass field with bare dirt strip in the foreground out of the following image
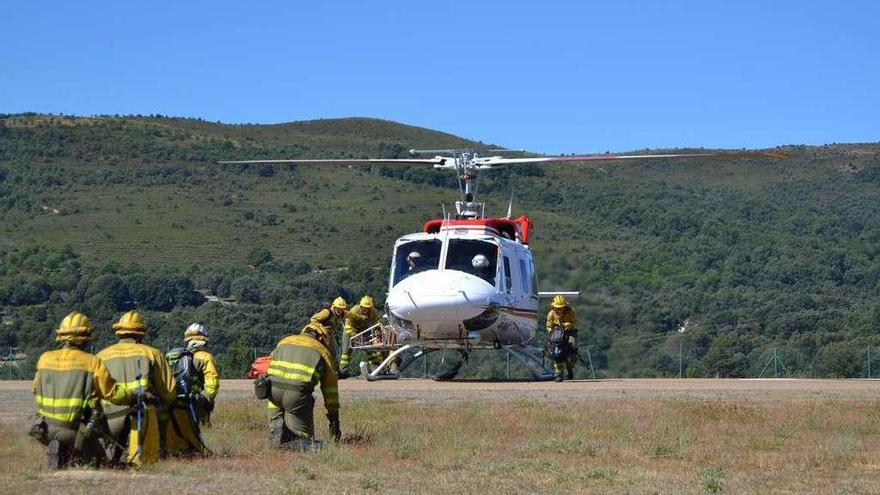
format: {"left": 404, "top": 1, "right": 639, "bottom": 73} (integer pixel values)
{"left": 0, "top": 380, "right": 880, "bottom": 494}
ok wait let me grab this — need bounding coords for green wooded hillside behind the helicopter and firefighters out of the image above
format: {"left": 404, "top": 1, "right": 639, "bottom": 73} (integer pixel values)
{"left": 0, "top": 115, "right": 880, "bottom": 376}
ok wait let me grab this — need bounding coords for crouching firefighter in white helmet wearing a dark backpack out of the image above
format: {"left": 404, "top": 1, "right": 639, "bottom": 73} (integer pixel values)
{"left": 163, "top": 323, "right": 220, "bottom": 455}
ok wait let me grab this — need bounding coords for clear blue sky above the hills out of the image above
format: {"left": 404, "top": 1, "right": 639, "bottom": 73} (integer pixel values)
{"left": 0, "top": 0, "right": 880, "bottom": 153}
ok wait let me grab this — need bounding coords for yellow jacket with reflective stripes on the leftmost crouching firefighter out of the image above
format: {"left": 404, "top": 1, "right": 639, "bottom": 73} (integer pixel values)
{"left": 32, "top": 347, "right": 129, "bottom": 428}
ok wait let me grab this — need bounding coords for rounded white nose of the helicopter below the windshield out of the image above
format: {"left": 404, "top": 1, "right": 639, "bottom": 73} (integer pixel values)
{"left": 388, "top": 270, "right": 495, "bottom": 323}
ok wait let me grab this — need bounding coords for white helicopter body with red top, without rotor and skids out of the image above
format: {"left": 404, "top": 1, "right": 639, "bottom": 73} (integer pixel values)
{"left": 387, "top": 217, "right": 538, "bottom": 350}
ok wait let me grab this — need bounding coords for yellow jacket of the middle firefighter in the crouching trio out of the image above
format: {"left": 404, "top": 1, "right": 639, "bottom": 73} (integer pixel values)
{"left": 98, "top": 339, "right": 177, "bottom": 405}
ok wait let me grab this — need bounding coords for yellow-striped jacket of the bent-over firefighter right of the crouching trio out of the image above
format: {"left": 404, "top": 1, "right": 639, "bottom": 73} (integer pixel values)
{"left": 267, "top": 335, "right": 339, "bottom": 412}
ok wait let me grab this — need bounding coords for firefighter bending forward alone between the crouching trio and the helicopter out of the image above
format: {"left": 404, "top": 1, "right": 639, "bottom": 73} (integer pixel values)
{"left": 267, "top": 323, "right": 342, "bottom": 450}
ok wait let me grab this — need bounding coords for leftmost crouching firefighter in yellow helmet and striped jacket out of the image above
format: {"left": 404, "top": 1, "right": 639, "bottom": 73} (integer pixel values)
{"left": 30, "top": 311, "right": 129, "bottom": 469}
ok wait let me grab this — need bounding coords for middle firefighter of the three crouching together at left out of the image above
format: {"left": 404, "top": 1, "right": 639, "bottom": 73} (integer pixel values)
{"left": 98, "top": 311, "right": 177, "bottom": 467}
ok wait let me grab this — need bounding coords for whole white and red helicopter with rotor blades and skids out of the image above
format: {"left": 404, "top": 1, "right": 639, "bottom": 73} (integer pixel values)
{"left": 219, "top": 149, "right": 785, "bottom": 381}
